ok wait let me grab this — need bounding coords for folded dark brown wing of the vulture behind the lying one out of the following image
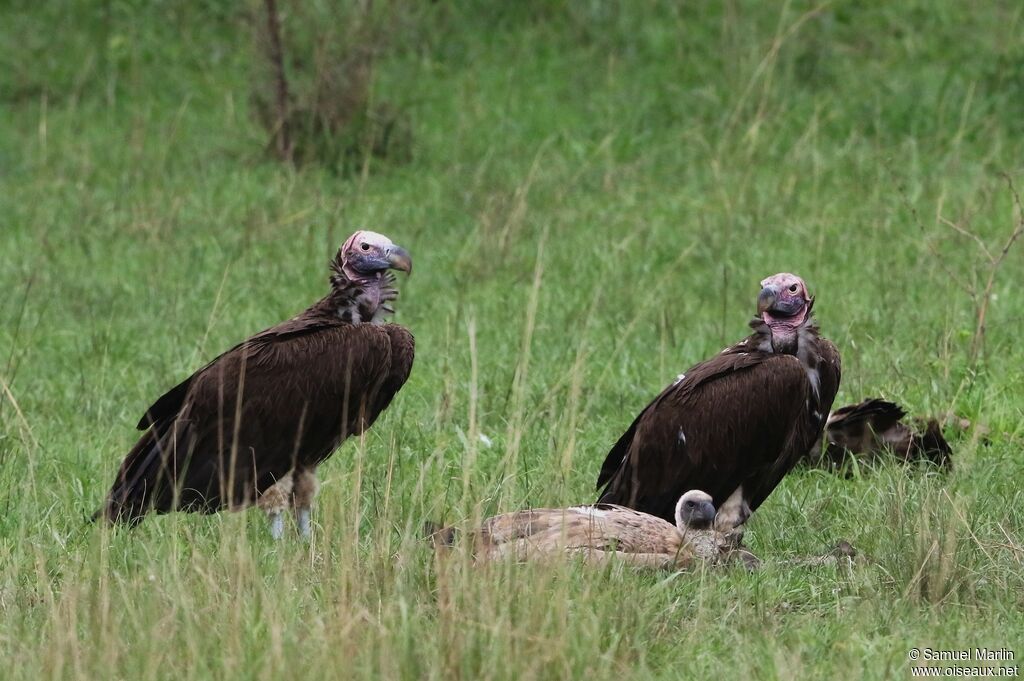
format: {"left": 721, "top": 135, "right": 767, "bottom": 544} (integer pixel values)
{"left": 599, "top": 346, "right": 813, "bottom": 521}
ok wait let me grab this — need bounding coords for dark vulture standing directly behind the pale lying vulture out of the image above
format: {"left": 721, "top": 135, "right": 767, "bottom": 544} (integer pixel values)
{"left": 597, "top": 273, "right": 840, "bottom": 539}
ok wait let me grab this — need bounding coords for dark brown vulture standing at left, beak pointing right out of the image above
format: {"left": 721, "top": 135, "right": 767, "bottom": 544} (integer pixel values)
{"left": 94, "top": 231, "right": 414, "bottom": 539}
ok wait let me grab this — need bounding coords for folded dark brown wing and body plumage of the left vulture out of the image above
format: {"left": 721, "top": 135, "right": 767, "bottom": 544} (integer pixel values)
{"left": 100, "top": 317, "right": 414, "bottom": 519}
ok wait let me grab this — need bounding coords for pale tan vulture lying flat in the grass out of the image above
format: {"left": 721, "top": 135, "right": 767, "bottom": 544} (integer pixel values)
{"left": 432, "top": 490, "right": 756, "bottom": 569}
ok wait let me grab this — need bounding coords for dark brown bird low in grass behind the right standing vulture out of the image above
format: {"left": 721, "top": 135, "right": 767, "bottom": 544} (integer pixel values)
{"left": 807, "top": 397, "right": 952, "bottom": 469}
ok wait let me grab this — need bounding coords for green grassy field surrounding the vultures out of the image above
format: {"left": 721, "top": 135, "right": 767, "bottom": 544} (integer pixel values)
{"left": 0, "top": 0, "right": 1024, "bottom": 681}
